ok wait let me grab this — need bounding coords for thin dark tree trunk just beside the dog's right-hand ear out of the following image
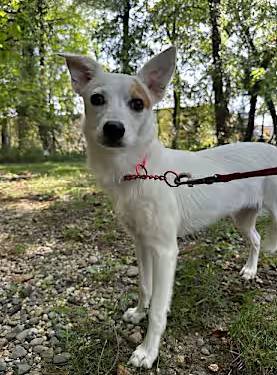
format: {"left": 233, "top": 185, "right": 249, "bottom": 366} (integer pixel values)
{"left": 171, "top": 68, "right": 181, "bottom": 149}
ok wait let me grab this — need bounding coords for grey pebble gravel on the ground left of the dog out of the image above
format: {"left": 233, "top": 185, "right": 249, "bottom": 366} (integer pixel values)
{"left": 0, "top": 189, "right": 141, "bottom": 375}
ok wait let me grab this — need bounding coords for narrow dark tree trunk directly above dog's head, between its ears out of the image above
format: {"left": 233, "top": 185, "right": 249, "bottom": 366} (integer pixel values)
{"left": 121, "top": 0, "right": 131, "bottom": 74}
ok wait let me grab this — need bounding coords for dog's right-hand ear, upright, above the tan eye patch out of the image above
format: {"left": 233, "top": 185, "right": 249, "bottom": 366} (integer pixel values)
{"left": 138, "top": 46, "right": 176, "bottom": 104}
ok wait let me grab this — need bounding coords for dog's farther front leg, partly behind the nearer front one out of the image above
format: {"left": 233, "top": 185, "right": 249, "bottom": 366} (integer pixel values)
{"left": 123, "top": 241, "right": 153, "bottom": 324}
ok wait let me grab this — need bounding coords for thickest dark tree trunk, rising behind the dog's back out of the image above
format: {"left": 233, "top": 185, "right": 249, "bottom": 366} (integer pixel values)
{"left": 209, "top": 0, "right": 229, "bottom": 144}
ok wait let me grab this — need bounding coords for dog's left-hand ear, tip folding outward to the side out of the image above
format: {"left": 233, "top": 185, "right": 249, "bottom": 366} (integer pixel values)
{"left": 58, "top": 53, "right": 101, "bottom": 94}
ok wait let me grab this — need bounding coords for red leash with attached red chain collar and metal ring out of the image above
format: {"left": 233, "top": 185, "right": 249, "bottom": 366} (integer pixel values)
{"left": 123, "top": 164, "right": 277, "bottom": 187}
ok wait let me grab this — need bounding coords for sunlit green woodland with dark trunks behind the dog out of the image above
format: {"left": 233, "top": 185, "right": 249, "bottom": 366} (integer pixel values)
{"left": 0, "top": 0, "right": 277, "bottom": 162}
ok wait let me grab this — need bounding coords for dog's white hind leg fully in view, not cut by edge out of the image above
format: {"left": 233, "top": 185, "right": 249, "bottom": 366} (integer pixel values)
{"left": 233, "top": 208, "right": 261, "bottom": 280}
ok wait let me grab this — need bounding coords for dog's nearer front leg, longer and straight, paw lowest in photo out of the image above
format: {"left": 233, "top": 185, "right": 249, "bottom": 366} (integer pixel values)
{"left": 130, "top": 239, "right": 178, "bottom": 368}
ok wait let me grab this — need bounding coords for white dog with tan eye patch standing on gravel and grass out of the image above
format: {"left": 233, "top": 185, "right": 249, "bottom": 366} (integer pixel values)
{"left": 62, "top": 47, "right": 277, "bottom": 368}
